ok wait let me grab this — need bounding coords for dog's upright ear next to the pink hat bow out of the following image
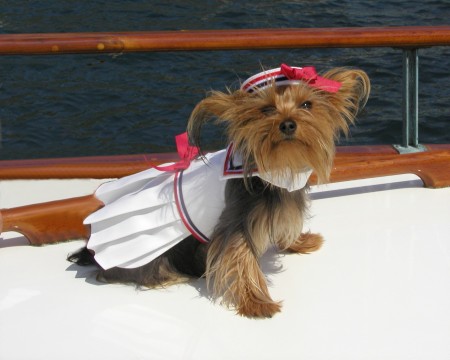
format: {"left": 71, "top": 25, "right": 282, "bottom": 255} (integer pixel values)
{"left": 323, "top": 68, "right": 370, "bottom": 135}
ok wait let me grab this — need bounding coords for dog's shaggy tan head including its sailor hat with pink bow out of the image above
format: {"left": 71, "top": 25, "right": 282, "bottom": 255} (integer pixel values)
{"left": 188, "top": 64, "right": 370, "bottom": 182}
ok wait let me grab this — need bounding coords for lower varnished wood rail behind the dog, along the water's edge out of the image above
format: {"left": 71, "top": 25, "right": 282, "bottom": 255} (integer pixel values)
{"left": 0, "top": 144, "right": 450, "bottom": 188}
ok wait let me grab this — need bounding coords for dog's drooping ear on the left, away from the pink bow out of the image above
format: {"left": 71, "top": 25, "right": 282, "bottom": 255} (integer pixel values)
{"left": 187, "top": 90, "right": 245, "bottom": 148}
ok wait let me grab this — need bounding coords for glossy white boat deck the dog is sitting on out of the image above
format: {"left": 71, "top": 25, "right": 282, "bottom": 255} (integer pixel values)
{"left": 0, "top": 175, "right": 450, "bottom": 360}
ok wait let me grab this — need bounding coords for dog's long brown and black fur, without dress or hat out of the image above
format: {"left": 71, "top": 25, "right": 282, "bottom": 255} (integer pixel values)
{"left": 72, "top": 68, "right": 370, "bottom": 317}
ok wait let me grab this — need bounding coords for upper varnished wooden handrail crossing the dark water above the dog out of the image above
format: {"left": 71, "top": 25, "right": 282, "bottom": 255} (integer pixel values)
{"left": 0, "top": 26, "right": 450, "bottom": 55}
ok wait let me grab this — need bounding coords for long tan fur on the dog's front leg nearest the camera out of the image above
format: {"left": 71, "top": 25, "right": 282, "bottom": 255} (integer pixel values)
{"left": 206, "top": 235, "right": 281, "bottom": 317}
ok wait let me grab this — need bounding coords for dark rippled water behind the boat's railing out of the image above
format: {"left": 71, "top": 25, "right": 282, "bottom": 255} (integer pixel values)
{"left": 0, "top": 0, "right": 450, "bottom": 159}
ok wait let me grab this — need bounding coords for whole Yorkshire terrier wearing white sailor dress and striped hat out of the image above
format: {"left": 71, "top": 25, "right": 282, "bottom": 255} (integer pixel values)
{"left": 69, "top": 64, "right": 370, "bottom": 317}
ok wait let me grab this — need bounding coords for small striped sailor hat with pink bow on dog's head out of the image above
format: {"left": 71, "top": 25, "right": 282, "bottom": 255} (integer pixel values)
{"left": 241, "top": 64, "right": 342, "bottom": 93}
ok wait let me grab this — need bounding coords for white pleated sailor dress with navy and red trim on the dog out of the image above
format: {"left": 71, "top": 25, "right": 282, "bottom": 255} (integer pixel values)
{"left": 84, "top": 134, "right": 311, "bottom": 270}
